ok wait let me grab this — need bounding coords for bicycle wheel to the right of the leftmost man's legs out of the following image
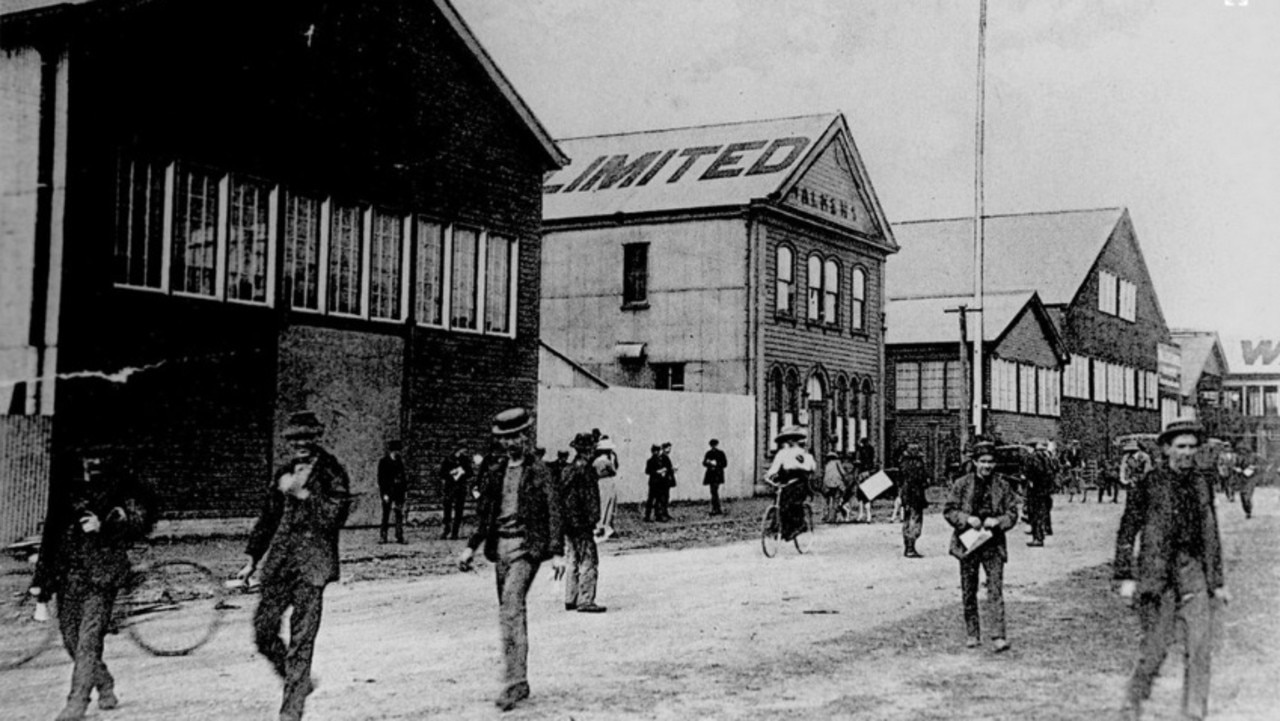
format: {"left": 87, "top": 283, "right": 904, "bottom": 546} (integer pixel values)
{"left": 115, "top": 561, "right": 224, "bottom": 656}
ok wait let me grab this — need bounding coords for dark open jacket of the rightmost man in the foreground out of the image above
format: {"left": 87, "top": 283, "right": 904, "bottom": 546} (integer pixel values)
{"left": 1114, "top": 465, "right": 1222, "bottom": 594}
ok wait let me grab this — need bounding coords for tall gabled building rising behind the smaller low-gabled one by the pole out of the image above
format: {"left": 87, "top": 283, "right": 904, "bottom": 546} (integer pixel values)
{"left": 887, "top": 207, "right": 1179, "bottom": 461}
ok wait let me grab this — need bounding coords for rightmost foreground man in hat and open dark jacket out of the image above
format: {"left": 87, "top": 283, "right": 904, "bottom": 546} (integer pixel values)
{"left": 1114, "top": 419, "right": 1231, "bottom": 720}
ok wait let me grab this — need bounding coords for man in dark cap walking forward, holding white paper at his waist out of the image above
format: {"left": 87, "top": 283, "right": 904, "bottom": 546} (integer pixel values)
{"left": 942, "top": 441, "right": 1018, "bottom": 653}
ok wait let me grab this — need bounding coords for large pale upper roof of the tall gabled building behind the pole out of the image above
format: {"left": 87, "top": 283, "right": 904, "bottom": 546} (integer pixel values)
{"left": 886, "top": 207, "right": 1125, "bottom": 305}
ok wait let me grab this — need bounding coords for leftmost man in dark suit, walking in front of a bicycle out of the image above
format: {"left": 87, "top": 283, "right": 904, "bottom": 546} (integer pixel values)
{"left": 29, "top": 448, "right": 155, "bottom": 721}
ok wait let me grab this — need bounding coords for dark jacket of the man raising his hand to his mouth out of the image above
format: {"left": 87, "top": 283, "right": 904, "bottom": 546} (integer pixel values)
{"left": 244, "top": 448, "right": 351, "bottom": 585}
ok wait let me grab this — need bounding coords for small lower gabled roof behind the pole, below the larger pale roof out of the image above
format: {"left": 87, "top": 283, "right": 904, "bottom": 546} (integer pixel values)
{"left": 884, "top": 291, "right": 1066, "bottom": 359}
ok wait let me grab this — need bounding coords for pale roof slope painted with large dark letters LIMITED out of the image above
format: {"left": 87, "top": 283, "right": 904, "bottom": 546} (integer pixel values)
{"left": 543, "top": 113, "right": 834, "bottom": 220}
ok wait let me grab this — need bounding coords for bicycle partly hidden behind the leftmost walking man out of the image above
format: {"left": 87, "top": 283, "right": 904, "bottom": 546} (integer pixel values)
{"left": 0, "top": 542, "right": 228, "bottom": 670}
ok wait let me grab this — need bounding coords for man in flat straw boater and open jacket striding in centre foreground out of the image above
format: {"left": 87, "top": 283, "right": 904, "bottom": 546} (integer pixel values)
{"left": 458, "top": 409, "right": 564, "bottom": 711}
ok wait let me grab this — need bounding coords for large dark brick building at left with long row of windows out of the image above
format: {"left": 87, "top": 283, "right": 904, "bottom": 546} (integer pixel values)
{"left": 0, "top": 0, "right": 564, "bottom": 525}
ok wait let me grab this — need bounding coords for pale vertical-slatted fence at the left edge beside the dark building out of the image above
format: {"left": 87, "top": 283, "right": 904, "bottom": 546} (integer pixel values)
{"left": 0, "top": 415, "right": 54, "bottom": 546}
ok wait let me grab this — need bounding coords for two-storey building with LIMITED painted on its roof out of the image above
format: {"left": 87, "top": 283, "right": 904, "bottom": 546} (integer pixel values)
{"left": 541, "top": 114, "right": 897, "bottom": 473}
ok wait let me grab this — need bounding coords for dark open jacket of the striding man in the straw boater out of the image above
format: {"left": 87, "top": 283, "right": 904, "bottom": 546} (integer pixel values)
{"left": 467, "top": 453, "right": 568, "bottom": 562}
